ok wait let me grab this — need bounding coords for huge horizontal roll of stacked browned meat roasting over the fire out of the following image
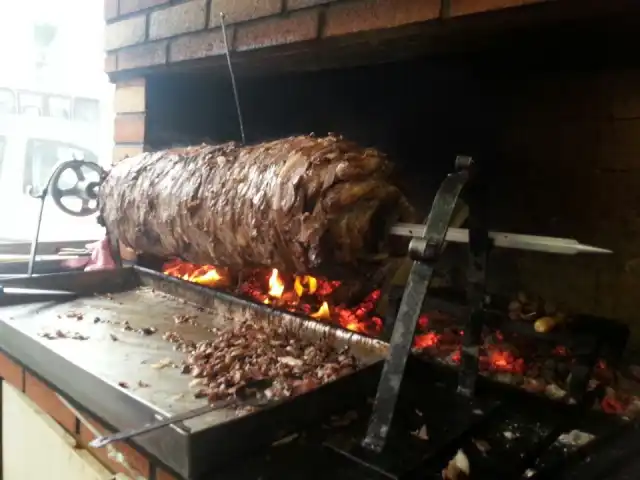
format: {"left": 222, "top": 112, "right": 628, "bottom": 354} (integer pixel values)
{"left": 99, "top": 136, "right": 413, "bottom": 279}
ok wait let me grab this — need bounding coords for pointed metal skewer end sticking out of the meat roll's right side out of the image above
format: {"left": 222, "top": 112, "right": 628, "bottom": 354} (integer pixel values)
{"left": 391, "top": 223, "right": 613, "bottom": 255}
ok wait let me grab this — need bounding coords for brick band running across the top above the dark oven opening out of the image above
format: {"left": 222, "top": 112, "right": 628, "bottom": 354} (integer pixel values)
{"left": 105, "top": 0, "right": 548, "bottom": 73}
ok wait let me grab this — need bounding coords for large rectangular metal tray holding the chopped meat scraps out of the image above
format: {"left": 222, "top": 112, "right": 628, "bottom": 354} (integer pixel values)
{"left": 0, "top": 267, "right": 388, "bottom": 479}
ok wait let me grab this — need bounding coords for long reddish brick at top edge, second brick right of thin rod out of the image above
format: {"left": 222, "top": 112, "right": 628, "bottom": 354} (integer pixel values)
{"left": 324, "top": 0, "right": 440, "bottom": 37}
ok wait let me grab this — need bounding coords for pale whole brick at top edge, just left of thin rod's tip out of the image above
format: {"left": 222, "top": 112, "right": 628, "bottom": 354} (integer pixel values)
{"left": 149, "top": 0, "right": 207, "bottom": 40}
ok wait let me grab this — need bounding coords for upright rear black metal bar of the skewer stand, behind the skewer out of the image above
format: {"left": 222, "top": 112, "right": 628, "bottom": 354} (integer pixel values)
{"left": 458, "top": 161, "right": 491, "bottom": 396}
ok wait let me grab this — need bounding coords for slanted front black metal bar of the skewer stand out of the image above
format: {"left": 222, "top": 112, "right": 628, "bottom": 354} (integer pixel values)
{"left": 362, "top": 165, "right": 469, "bottom": 452}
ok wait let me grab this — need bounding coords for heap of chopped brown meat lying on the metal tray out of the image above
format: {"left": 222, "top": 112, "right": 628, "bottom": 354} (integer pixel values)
{"left": 164, "top": 321, "right": 358, "bottom": 402}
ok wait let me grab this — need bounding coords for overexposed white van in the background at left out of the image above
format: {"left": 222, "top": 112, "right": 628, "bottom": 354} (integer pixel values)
{"left": 0, "top": 89, "right": 106, "bottom": 242}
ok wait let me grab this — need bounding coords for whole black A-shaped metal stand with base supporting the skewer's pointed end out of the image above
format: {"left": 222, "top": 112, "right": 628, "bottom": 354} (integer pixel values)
{"left": 327, "top": 156, "right": 496, "bottom": 479}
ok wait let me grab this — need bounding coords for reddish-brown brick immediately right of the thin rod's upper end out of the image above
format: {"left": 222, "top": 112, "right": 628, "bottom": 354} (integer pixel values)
{"left": 235, "top": 10, "right": 319, "bottom": 50}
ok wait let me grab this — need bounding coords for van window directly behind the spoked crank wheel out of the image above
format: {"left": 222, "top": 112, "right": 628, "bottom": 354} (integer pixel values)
{"left": 23, "top": 140, "right": 98, "bottom": 191}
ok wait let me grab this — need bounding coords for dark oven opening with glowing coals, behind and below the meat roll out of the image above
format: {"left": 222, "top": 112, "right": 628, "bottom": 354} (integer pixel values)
{"left": 132, "top": 31, "right": 640, "bottom": 413}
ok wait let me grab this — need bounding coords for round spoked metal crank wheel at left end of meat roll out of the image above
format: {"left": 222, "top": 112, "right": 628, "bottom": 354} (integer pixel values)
{"left": 49, "top": 160, "right": 105, "bottom": 217}
